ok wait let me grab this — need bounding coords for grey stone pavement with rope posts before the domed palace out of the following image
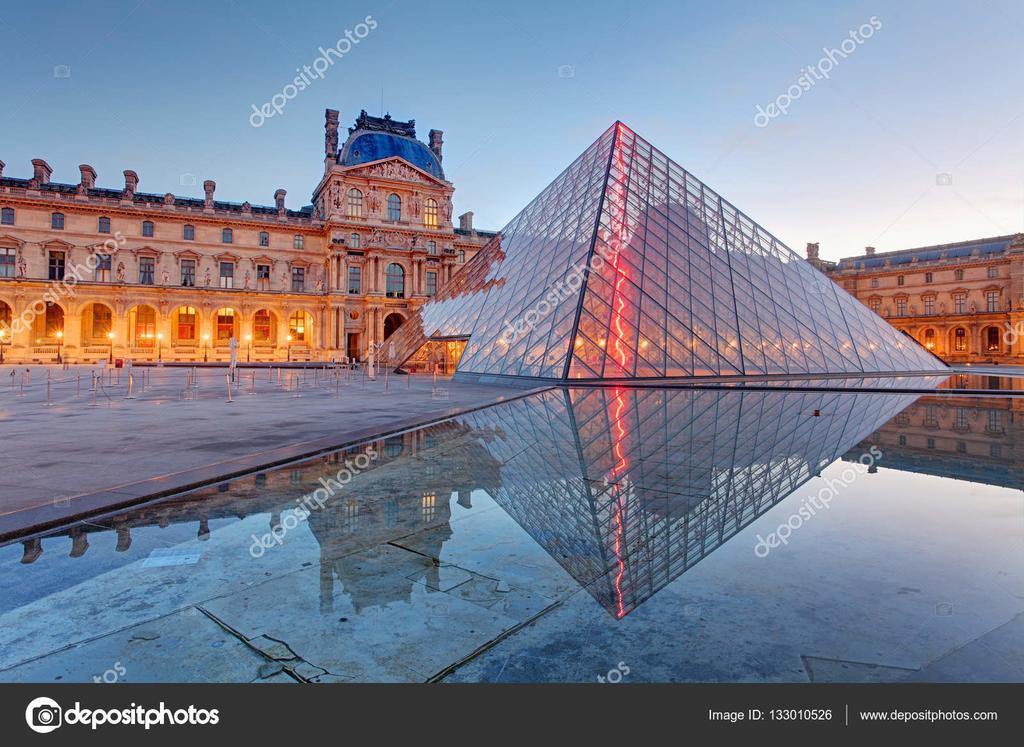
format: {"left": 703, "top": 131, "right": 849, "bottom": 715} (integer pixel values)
{"left": 0, "top": 366, "right": 523, "bottom": 540}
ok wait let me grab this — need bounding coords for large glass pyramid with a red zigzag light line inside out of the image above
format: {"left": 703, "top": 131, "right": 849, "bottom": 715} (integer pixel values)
{"left": 391, "top": 122, "right": 945, "bottom": 380}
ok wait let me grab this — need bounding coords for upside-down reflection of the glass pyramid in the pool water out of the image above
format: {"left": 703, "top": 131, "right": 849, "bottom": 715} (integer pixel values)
{"left": 459, "top": 387, "right": 915, "bottom": 618}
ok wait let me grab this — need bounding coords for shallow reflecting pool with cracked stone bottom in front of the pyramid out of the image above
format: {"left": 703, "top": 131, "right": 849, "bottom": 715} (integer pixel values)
{"left": 0, "top": 381, "right": 1024, "bottom": 682}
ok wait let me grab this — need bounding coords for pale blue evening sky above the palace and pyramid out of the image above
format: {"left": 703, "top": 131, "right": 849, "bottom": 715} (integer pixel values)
{"left": 0, "top": 0, "right": 1024, "bottom": 259}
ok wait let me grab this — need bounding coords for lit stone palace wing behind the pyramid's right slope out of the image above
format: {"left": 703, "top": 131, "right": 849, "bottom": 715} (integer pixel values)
{"left": 819, "top": 234, "right": 1024, "bottom": 365}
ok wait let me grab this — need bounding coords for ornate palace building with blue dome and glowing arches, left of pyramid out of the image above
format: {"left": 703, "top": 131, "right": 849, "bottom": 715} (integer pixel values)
{"left": 0, "top": 110, "right": 494, "bottom": 363}
